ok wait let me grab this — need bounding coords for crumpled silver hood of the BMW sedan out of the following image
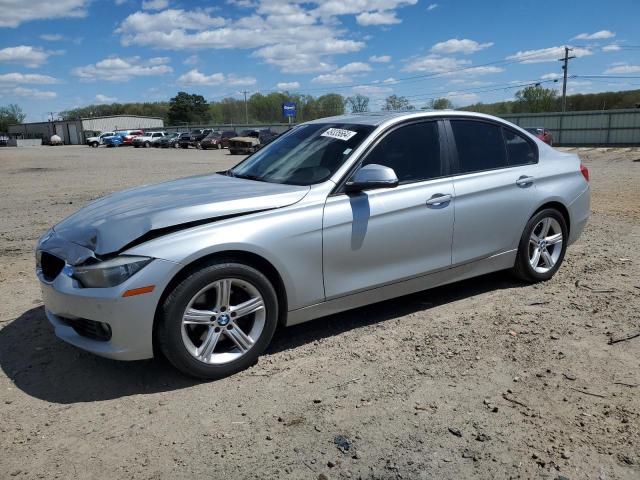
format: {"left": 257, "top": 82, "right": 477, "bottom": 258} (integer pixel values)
{"left": 54, "top": 174, "right": 309, "bottom": 256}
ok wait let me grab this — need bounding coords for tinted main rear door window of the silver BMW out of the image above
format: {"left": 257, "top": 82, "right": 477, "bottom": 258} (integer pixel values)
{"left": 451, "top": 120, "right": 507, "bottom": 173}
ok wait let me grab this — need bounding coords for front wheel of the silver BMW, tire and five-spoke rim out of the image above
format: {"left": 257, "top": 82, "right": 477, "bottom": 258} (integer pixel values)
{"left": 158, "top": 261, "right": 278, "bottom": 379}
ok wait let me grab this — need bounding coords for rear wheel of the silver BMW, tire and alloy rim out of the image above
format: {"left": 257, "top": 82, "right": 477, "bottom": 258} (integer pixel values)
{"left": 514, "top": 209, "right": 568, "bottom": 282}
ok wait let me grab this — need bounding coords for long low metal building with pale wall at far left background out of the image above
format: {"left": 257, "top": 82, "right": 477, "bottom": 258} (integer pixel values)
{"left": 9, "top": 115, "right": 164, "bottom": 145}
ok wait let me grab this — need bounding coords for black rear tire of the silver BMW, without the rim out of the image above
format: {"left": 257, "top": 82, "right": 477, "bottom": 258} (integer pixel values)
{"left": 512, "top": 208, "right": 569, "bottom": 283}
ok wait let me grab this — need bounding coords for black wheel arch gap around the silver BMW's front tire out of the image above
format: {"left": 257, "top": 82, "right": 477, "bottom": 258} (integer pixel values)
{"left": 152, "top": 250, "right": 288, "bottom": 356}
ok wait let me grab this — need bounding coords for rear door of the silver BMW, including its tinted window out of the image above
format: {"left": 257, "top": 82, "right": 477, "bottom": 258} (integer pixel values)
{"left": 447, "top": 118, "right": 538, "bottom": 266}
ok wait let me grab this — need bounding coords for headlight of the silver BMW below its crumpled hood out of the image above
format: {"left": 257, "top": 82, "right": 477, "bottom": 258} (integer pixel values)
{"left": 68, "top": 255, "right": 153, "bottom": 288}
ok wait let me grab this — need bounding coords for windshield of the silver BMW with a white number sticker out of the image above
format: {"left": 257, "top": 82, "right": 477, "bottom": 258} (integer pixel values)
{"left": 228, "top": 123, "right": 374, "bottom": 185}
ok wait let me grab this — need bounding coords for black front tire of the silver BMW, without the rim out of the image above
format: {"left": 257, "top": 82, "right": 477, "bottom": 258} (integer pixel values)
{"left": 157, "top": 259, "right": 278, "bottom": 380}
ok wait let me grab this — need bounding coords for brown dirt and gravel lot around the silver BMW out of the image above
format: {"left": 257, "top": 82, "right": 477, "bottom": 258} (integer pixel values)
{"left": 0, "top": 147, "right": 640, "bottom": 479}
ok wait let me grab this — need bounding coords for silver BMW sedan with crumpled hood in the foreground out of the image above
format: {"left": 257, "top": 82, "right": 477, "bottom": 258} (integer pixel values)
{"left": 36, "top": 111, "right": 590, "bottom": 378}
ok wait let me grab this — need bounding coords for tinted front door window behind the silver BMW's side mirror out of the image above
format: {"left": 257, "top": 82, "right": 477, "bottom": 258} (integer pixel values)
{"left": 363, "top": 122, "right": 442, "bottom": 183}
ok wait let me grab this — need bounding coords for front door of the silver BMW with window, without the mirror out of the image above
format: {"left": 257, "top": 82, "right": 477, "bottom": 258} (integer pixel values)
{"left": 323, "top": 121, "right": 453, "bottom": 299}
